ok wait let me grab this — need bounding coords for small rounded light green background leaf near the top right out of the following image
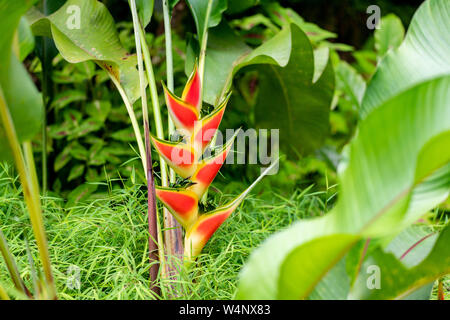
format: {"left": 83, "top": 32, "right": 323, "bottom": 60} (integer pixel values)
{"left": 374, "top": 13, "right": 405, "bottom": 57}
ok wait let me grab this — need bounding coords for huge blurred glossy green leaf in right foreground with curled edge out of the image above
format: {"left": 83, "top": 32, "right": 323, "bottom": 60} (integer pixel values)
{"left": 238, "top": 77, "right": 450, "bottom": 299}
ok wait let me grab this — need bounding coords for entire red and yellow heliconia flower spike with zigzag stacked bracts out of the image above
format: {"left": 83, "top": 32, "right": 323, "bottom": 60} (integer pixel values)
{"left": 151, "top": 67, "right": 266, "bottom": 261}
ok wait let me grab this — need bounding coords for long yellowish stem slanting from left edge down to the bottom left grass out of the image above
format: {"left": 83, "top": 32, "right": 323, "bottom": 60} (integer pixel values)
{"left": 0, "top": 88, "right": 56, "bottom": 299}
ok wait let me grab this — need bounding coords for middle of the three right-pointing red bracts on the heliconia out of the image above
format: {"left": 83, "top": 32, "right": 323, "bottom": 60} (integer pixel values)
{"left": 188, "top": 131, "right": 239, "bottom": 199}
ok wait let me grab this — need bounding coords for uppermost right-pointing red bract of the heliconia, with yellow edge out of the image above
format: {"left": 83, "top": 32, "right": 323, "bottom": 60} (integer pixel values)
{"left": 191, "top": 93, "right": 231, "bottom": 154}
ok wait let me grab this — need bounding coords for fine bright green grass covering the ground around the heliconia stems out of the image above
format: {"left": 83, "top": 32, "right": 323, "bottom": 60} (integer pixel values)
{"left": 0, "top": 164, "right": 450, "bottom": 300}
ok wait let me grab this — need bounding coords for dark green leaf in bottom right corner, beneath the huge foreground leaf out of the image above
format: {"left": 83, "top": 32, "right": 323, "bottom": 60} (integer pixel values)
{"left": 350, "top": 225, "right": 450, "bottom": 300}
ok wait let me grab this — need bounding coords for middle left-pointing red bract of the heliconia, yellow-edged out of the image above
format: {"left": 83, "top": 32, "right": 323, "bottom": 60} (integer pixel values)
{"left": 150, "top": 135, "right": 197, "bottom": 178}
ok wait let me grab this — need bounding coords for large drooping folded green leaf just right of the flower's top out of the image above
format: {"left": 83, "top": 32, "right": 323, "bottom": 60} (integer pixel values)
{"left": 191, "top": 24, "right": 334, "bottom": 153}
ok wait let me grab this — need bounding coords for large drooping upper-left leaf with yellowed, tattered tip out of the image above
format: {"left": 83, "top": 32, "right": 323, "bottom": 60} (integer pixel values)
{"left": 28, "top": 0, "right": 140, "bottom": 102}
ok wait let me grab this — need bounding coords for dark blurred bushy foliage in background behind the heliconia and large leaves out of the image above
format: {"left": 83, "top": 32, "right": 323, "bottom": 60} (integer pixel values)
{"left": 22, "top": 0, "right": 422, "bottom": 206}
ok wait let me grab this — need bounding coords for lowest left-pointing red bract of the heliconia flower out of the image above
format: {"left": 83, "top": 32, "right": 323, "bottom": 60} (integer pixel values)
{"left": 156, "top": 187, "right": 198, "bottom": 229}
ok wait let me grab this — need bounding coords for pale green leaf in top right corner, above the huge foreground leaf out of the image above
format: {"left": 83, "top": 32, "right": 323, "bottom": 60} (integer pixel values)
{"left": 361, "top": 0, "right": 450, "bottom": 118}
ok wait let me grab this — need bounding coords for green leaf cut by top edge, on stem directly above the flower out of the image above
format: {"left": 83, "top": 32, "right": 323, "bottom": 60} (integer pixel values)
{"left": 186, "top": 0, "right": 227, "bottom": 40}
